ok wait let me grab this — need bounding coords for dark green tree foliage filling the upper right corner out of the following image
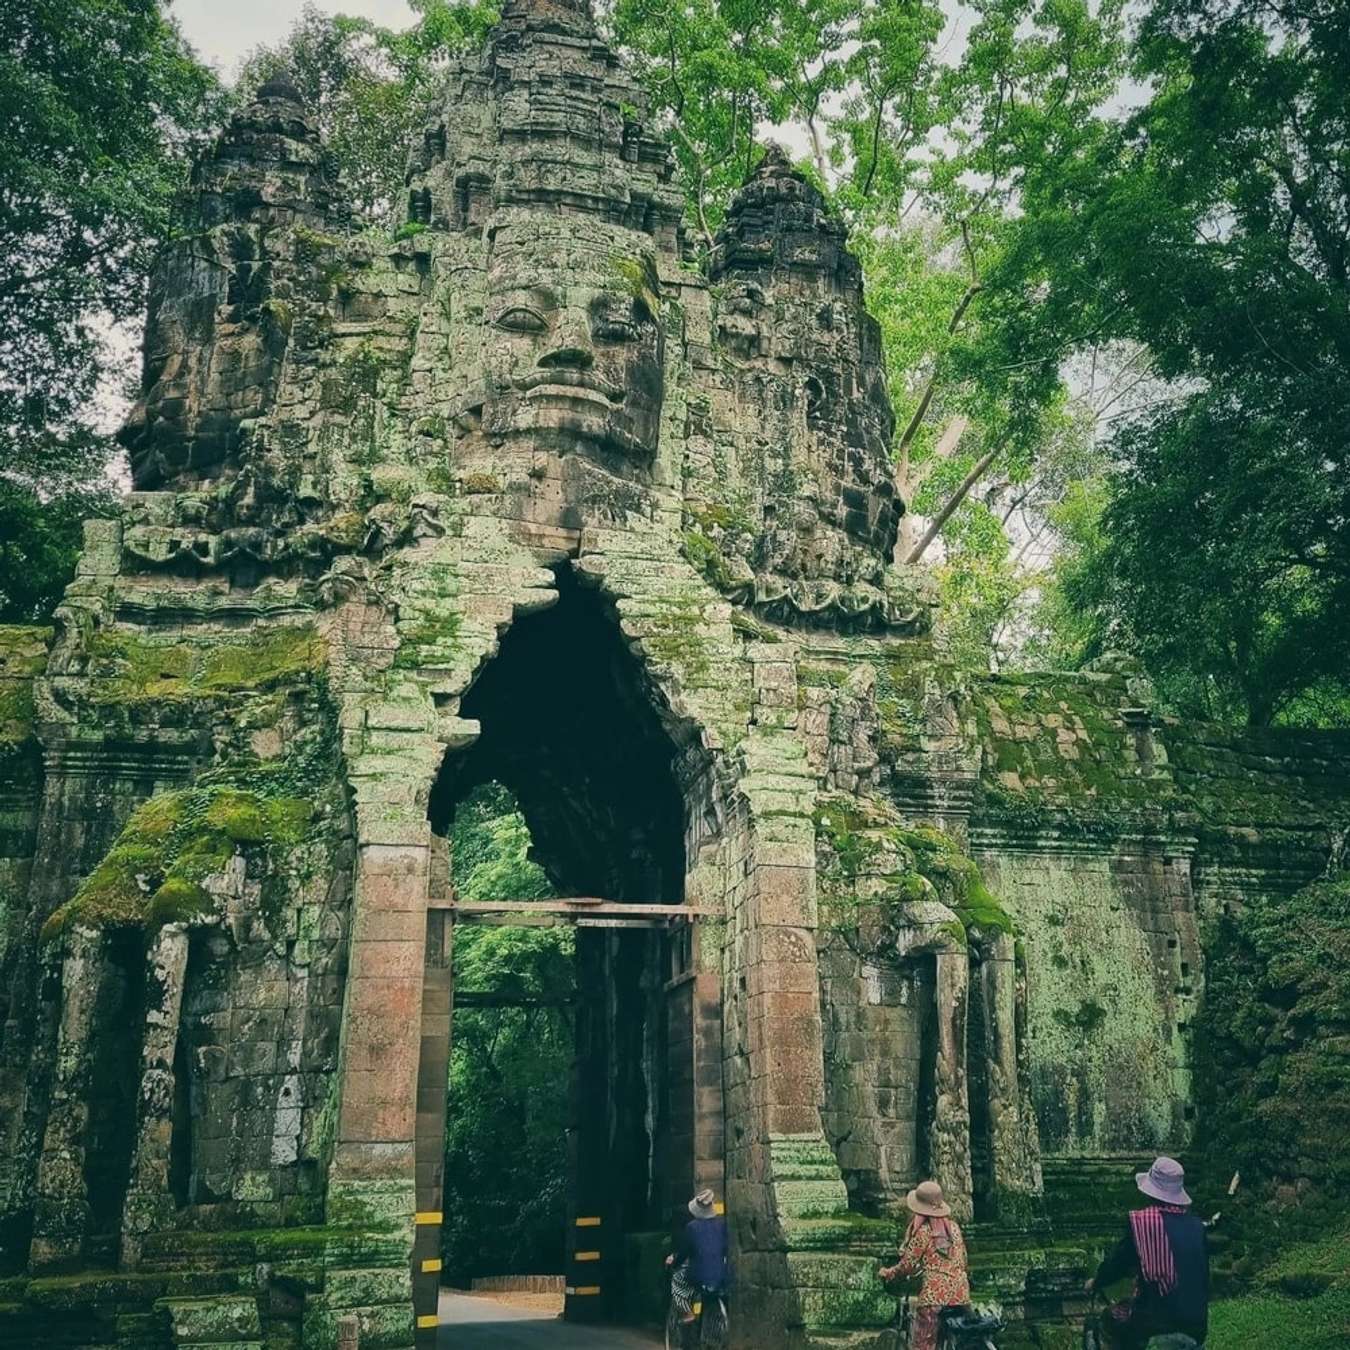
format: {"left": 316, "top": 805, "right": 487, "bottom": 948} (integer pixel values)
{"left": 990, "top": 0, "right": 1350, "bottom": 725}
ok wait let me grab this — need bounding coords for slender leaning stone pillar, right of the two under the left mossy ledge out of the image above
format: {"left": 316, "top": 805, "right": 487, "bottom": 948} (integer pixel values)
{"left": 122, "top": 923, "right": 189, "bottom": 1269}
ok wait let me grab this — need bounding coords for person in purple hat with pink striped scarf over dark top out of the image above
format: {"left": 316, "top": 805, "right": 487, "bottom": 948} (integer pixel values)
{"left": 1088, "top": 1158, "right": 1210, "bottom": 1350}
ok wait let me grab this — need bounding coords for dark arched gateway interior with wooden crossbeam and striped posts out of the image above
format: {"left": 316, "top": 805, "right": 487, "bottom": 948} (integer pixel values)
{"left": 414, "top": 570, "right": 721, "bottom": 1320}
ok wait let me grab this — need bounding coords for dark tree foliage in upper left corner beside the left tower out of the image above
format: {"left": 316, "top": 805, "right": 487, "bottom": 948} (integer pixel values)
{"left": 0, "top": 0, "right": 219, "bottom": 480}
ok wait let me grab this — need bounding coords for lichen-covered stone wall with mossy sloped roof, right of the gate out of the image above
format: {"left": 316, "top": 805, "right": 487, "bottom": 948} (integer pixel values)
{"left": 963, "top": 670, "right": 1350, "bottom": 1199}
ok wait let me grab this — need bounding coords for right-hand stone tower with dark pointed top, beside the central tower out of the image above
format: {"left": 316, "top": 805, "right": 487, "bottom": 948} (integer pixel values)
{"left": 709, "top": 146, "right": 903, "bottom": 604}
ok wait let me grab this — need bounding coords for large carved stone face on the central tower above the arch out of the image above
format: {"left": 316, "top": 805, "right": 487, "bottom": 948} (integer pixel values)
{"left": 482, "top": 217, "right": 664, "bottom": 464}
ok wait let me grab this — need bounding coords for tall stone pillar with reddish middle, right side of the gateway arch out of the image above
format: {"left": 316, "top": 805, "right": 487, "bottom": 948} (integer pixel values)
{"left": 725, "top": 644, "right": 848, "bottom": 1346}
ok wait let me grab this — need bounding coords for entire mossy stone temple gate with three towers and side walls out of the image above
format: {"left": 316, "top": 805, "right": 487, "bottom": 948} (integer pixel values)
{"left": 0, "top": 0, "right": 1347, "bottom": 1350}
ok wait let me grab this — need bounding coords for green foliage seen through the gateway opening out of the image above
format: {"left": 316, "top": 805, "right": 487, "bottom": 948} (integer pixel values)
{"left": 441, "top": 783, "right": 574, "bottom": 1280}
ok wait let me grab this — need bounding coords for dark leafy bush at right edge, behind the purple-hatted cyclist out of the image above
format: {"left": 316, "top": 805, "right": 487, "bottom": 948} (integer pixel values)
{"left": 1193, "top": 873, "right": 1350, "bottom": 1197}
